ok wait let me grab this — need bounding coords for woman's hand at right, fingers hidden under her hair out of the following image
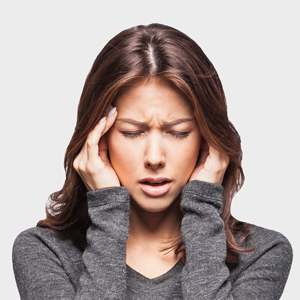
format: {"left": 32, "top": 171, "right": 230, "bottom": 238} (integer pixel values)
{"left": 189, "top": 140, "right": 230, "bottom": 184}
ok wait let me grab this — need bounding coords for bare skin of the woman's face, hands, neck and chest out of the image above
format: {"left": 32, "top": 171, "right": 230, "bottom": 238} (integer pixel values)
{"left": 73, "top": 80, "right": 229, "bottom": 278}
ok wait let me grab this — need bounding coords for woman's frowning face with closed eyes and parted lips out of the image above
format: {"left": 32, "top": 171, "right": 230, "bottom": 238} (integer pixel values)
{"left": 106, "top": 80, "right": 201, "bottom": 212}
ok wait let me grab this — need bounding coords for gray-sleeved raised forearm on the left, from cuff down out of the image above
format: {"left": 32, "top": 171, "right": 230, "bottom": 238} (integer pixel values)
{"left": 76, "top": 187, "right": 130, "bottom": 299}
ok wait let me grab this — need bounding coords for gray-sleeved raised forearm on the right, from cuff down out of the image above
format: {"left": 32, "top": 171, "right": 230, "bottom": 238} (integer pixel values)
{"left": 181, "top": 180, "right": 233, "bottom": 300}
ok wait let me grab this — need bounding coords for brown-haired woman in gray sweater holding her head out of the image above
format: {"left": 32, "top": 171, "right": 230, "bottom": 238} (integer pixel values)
{"left": 13, "top": 24, "right": 293, "bottom": 300}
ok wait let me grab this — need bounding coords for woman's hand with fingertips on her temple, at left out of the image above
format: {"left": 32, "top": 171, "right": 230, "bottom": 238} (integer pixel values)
{"left": 73, "top": 107, "right": 120, "bottom": 191}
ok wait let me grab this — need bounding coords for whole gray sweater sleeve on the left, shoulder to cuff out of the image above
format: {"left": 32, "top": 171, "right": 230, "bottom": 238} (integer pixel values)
{"left": 13, "top": 187, "right": 130, "bottom": 300}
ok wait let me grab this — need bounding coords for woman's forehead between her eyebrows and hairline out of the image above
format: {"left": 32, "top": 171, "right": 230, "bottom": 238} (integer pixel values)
{"left": 114, "top": 80, "right": 194, "bottom": 119}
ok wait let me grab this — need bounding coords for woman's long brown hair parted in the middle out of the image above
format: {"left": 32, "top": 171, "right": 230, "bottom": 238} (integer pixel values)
{"left": 37, "top": 24, "right": 256, "bottom": 263}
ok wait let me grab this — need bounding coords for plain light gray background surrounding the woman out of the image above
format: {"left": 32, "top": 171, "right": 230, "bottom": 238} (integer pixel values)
{"left": 0, "top": 0, "right": 300, "bottom": 300}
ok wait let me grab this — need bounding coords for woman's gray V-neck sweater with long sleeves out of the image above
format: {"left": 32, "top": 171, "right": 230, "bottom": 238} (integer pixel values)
{"left": 13, "top": 180, "right": 293, "bottom": 300}
